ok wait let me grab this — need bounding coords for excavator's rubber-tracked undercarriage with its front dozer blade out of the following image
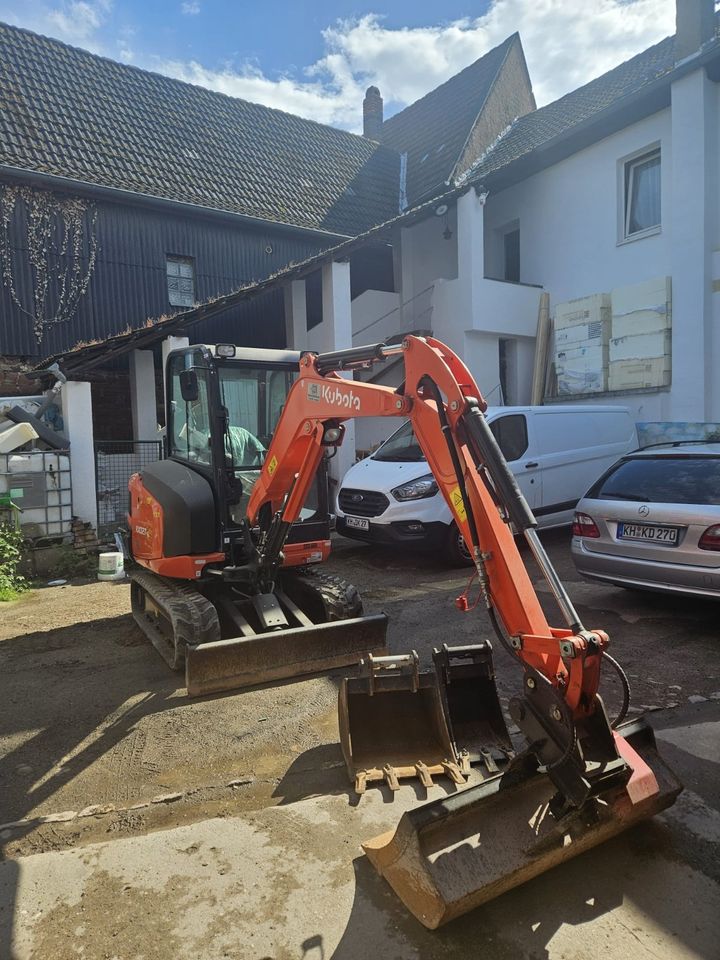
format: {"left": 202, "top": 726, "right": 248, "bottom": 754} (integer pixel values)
{"left": 131, "top": 567, "right": 387, "bottom": 696}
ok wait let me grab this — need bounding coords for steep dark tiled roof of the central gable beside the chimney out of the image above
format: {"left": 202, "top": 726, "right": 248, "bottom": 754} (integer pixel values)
{"left": 382, "top": 33, "right": 520, "bottom": 205}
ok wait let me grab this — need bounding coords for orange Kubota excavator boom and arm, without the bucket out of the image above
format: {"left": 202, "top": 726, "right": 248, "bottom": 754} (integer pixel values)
{"left": 248, "top": 336, "right": 631, "bottom": 806}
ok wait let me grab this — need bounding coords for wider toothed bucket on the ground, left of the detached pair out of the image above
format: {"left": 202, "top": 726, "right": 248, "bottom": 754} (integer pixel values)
{"left": 338, "top": 650, "right": 469, "bottom": 794}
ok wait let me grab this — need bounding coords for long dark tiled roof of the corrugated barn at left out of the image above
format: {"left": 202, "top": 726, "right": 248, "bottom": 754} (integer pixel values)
{"left": 0, "top": 24, "right": 399, "bottom": 235}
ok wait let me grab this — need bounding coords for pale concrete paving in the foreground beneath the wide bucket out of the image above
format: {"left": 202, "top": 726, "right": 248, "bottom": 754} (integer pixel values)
{"left": 0, "top": 701, "right": 720, "bottom": 960}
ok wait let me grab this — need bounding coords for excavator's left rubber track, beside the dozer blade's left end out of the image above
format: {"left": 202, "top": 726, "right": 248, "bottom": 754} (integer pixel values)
{"left": 131, "top": 570, "right": 220, "bottom": 670}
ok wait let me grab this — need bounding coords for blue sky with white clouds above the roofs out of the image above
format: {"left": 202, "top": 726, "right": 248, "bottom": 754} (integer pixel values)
{"left": 0, "top": 0, "right": 675, "bottom": 130}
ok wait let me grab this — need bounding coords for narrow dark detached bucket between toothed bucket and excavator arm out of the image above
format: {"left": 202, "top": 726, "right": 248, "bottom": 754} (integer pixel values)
{"left": 433, "top": 641, "right": 512, "bottom": 775}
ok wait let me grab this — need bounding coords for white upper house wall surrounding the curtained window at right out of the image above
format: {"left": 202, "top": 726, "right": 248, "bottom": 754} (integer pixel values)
{"left": 485, "top": 88, "right": 720, "bottom": 420}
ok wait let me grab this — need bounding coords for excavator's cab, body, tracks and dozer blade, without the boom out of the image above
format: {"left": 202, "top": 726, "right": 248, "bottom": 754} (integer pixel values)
{"left": 128, "top": 344, "right": 386, "bottom": 695}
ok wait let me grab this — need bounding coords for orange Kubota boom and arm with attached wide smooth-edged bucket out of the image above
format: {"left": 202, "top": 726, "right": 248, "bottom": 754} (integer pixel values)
{"left": 239, "top": 336, "right": 682, "bottom": 928}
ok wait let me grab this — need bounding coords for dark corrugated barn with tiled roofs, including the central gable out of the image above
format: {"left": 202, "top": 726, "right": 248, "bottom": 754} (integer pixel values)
{"left": 0, "top": 25, "right": 534, "bottom": 372}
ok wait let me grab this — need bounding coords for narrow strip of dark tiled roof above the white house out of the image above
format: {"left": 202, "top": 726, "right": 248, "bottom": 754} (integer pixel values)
{"left": 467, "top": 37, "right": 675, "bottom": 181}
